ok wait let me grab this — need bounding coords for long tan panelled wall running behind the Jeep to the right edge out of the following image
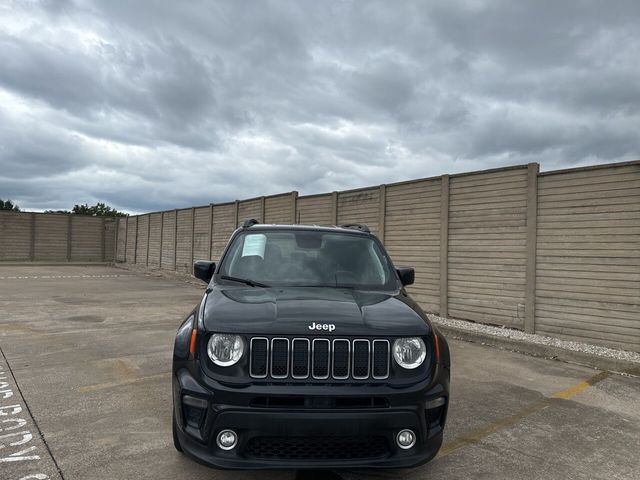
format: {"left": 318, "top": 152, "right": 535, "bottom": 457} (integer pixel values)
{"left": 109, "top": 161, "right": 640, "bottom": 351}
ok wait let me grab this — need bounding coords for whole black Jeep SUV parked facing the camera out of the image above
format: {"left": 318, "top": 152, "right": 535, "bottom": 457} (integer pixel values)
{"left": 173, "top": 220, "right": 450, "bottom": 469}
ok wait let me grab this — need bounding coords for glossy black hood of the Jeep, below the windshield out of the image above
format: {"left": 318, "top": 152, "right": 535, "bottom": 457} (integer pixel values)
{"left": 204, "top": 284, "right": 430, "bottom": 337}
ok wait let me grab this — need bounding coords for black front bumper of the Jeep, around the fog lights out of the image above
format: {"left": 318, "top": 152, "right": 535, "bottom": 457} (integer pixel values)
{"left": 173, "top": 368, "right": 449, "bottom": 469}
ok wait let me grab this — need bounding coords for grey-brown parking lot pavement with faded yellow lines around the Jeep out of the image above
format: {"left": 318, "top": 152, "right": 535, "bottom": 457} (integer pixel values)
{"left": 0, "top": 266, "right": 640, "bottom": 480}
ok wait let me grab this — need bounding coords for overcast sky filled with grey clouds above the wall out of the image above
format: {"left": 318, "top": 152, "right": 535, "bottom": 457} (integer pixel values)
{"left": 0, "top": 0, "right": 640, "bottom": 212}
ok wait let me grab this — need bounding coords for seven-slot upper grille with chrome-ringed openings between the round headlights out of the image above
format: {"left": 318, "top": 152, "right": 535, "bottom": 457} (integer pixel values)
{"left": 249, "top": 337, "right": 390, "bottom": 380}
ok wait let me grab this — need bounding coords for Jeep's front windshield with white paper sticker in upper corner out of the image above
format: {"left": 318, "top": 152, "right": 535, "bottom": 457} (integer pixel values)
{"left": 218, "top": 230, "right": 398, "bottom": 290}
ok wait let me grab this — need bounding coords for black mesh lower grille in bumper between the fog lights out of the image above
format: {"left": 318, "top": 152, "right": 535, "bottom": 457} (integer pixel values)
{"left": 244, "top": 436, "right": 389, "bottom": 461}
